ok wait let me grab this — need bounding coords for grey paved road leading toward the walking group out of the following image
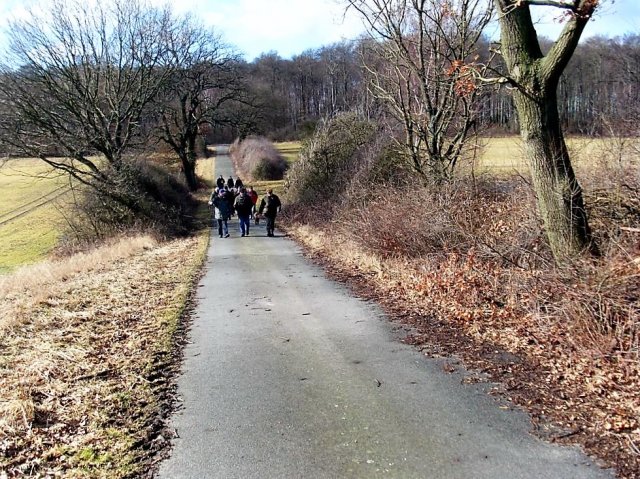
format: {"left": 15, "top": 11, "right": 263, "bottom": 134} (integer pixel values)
{"left": 160, "top": 148, "right": 613, "bottom": 479}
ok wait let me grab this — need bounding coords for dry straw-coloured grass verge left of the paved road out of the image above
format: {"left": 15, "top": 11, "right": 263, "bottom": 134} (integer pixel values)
{"left": 0, "top": 234, "right": 208, "bottom": 478}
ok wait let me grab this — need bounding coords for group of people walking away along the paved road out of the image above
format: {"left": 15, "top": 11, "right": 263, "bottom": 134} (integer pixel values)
{"left": 209, "top": 175, "right": 282, "bottom": 238}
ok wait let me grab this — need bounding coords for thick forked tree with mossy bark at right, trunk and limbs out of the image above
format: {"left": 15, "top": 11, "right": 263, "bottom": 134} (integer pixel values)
{"left": 494, "top": 0, "right": 599, "bottom": 261}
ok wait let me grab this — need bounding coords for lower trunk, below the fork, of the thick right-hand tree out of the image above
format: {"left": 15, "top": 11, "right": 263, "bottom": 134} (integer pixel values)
{"left": 514, "top": 85, "right": 596, "bottom": 261}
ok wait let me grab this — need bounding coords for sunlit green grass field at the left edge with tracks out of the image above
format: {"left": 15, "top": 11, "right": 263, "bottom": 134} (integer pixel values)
{"left": 0, "top": 159, "right": 67, "bottom": 274}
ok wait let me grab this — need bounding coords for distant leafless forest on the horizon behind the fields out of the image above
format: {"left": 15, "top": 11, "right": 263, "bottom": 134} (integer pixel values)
{"left": 214, "top": 34, "right": 640, "bottom": 142}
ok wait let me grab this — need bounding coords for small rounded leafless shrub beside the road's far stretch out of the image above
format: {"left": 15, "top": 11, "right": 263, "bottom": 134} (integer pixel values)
{"left": 229, "top": 136, "right": 288, "bottom": 180}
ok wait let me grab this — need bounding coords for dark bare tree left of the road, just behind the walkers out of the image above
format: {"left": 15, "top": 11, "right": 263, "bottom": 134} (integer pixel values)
{"left": 160, "top": 16, "right": 246, "bottom": 190}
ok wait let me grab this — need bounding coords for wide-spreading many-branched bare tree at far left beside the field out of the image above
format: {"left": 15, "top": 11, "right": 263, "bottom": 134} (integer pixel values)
{"left": 0, "top": 0, "right": 172, "bottom": 197}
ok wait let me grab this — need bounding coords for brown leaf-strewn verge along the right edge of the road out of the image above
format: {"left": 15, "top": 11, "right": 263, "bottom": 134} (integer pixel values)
{"left": 287, "top": 224, "right": 640, "bottom": 479}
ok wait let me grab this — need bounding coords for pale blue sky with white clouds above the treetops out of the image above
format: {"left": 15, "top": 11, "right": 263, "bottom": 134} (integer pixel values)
{"left": 0, "top": 0, "right": 640, "bottom": 60}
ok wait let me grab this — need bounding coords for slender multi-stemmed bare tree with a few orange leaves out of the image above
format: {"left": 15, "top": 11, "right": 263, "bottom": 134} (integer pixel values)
{"left": 348, "top": 0, "right": 492, "bottom": 182}
